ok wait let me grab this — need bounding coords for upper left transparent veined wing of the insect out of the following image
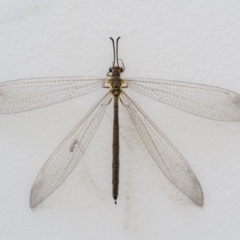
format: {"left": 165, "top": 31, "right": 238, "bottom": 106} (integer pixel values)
{"left": 0, "top": 77, "right": 104, "bottom": 113}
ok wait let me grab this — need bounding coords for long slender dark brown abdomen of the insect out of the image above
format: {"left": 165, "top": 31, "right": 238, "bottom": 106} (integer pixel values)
{"left": 112, "top": 96, "right": 119, "bottom": 204}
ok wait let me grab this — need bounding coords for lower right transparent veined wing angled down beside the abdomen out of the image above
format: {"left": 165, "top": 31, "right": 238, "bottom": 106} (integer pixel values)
{"left": 122, "top": 93, "right": 203, "bottom": 206}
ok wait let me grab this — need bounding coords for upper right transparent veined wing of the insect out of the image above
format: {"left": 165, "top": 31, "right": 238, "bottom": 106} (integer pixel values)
{"left": 126, "top": 79, "right": 240, "bottom": 121}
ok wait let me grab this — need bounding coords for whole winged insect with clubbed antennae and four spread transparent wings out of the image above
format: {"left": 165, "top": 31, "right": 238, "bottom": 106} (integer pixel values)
{"left": 0, "top": 37, "right": 240, "bottom": 208}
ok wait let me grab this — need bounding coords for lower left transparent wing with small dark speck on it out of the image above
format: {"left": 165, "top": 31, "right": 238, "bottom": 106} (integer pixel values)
{"left": 30, "top": 93, "right": 111, "bottom": 208}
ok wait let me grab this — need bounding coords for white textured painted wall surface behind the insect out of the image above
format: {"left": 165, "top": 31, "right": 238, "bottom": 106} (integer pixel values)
{"left": 0, "top": 0, "right": 240, "bottom": 240}
